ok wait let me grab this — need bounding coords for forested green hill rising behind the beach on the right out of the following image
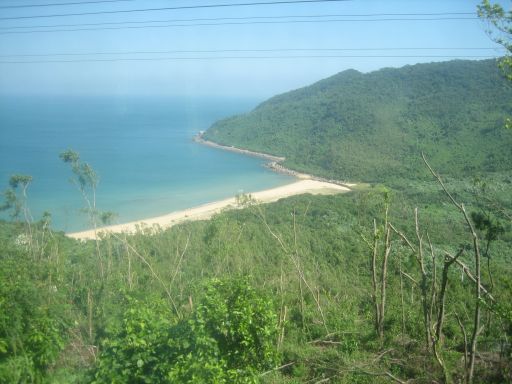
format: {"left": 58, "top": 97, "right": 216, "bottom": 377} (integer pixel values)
{"left": 205, "top": 60, "right": 512, "bottom": 182}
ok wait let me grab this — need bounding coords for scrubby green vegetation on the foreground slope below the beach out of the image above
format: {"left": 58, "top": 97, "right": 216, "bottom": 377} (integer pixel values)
{"left": 0, "top": 176, "right": 512, "bottom": 383}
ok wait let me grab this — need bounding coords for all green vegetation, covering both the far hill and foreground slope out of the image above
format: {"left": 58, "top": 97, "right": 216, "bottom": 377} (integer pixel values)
{"left": 0, "top": 58, "right": 512, "bottom": 384}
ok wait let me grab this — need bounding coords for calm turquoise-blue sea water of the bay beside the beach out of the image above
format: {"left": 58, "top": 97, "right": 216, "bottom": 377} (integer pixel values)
{"left": 0, "top": 97, "right": 291, "bottom": 231}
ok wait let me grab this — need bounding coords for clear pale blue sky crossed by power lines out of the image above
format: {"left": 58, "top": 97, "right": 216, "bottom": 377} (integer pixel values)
{"left": 0, "top": 0, "right": 503, "bottom": 99}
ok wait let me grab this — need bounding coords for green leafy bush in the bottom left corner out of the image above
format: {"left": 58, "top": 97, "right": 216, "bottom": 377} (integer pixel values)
{"left": 0, "top": 252, "right": 66, "bottom": 383}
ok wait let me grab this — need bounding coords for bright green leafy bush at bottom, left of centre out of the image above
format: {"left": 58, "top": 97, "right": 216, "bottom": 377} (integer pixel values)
{"left": 94, "top": 279, "right": 277, "bottom": 384}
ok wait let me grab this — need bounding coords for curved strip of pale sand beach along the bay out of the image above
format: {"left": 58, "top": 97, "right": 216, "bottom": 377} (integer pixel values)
{"left": 67, "top": 180, "right": 350, "bottom": 240}
